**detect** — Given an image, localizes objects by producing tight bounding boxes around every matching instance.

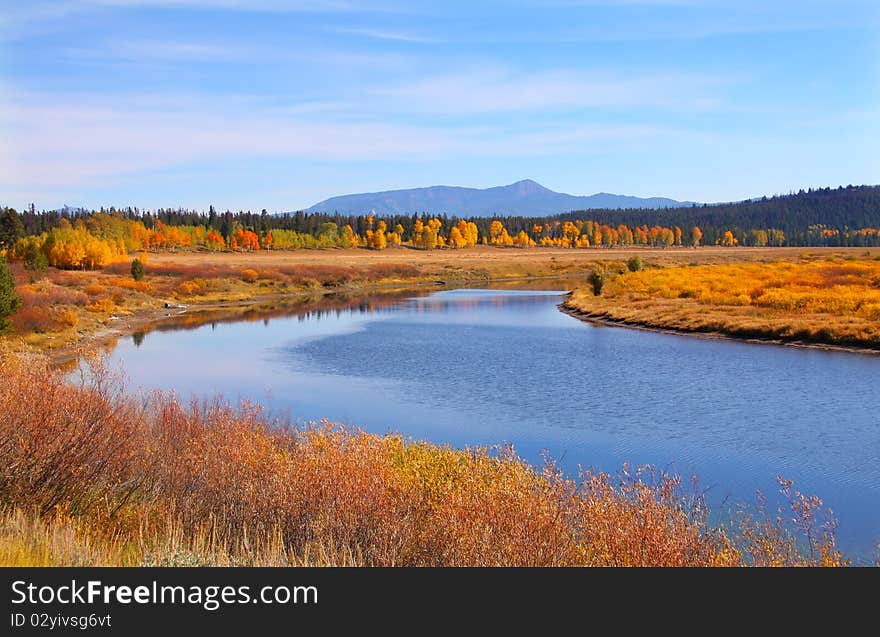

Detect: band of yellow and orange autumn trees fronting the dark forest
[0,205,812,270]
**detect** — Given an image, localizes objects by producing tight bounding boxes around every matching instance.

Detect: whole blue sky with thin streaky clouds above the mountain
[0,0,880,212]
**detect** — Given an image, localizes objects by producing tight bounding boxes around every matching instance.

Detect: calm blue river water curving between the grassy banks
[106,290,880,559]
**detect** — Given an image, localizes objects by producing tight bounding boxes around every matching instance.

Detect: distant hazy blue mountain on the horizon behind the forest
[305,179,691,216]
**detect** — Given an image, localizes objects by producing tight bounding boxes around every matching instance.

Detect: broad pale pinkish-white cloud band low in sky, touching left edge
[0,89,678,189]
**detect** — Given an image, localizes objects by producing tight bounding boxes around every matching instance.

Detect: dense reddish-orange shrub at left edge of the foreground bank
[0,352,139,514]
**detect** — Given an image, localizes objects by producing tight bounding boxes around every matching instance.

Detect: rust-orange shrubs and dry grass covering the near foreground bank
[0,350,843,566]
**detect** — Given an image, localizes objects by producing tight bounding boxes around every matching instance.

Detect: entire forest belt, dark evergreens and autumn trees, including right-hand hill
[0,186,880,267]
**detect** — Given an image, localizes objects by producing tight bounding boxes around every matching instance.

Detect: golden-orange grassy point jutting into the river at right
[566,257,880,349]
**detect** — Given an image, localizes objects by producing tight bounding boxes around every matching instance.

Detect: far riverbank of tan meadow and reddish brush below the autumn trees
[6,246,872,364]
